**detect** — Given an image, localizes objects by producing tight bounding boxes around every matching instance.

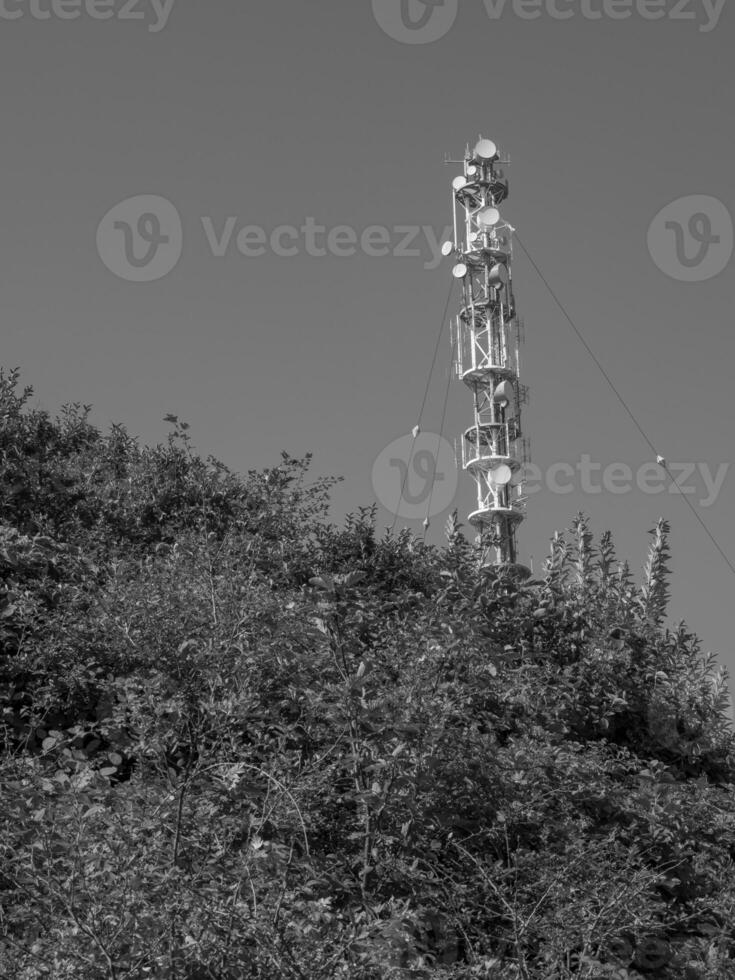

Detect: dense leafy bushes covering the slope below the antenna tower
[0,371,735,980]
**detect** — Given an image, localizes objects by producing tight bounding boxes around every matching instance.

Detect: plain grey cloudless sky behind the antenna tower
[0,0,735,704]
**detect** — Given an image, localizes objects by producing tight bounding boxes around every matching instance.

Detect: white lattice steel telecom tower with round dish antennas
[444,139,530,576]
